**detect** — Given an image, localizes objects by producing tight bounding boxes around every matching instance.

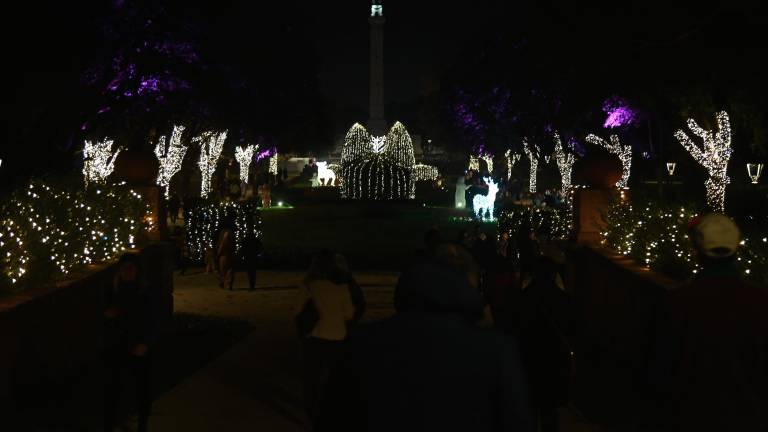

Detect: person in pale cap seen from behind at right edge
[651,214,768,432]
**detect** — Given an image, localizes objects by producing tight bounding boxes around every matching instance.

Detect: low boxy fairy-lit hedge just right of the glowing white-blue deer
[498,206,572,240]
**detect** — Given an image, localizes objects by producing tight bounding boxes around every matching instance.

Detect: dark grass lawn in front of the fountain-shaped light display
[262,200,496,270]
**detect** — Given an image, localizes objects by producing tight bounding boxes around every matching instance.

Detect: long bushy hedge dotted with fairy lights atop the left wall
[0,181,152,290]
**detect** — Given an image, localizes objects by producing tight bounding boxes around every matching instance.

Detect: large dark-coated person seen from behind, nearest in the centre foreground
[318,245,533,432]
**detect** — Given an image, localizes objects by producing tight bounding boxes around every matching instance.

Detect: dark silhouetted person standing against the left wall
[104,254,154,432]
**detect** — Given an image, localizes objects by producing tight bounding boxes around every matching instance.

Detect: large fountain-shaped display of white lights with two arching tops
[341,122,416,200]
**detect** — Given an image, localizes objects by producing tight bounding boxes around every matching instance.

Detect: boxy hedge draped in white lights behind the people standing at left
[185,200,261,262]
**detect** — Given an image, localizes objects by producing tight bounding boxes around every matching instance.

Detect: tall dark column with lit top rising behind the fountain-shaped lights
[368,0,387,136]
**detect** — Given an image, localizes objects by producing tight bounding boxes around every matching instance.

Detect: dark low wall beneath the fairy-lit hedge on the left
[0,243,174,414]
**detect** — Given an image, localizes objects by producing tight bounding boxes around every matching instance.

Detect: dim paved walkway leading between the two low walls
[138,270,601,432]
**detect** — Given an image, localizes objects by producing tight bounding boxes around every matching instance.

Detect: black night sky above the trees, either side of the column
[0,0,768,188]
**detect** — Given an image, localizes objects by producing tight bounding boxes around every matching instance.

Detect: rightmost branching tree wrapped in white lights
[675,111,733,212]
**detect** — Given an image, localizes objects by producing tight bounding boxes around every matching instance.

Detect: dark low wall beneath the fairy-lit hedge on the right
[569,246,679,426]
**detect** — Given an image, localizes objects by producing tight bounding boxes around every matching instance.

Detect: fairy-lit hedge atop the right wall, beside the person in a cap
[601,201,768,285]
